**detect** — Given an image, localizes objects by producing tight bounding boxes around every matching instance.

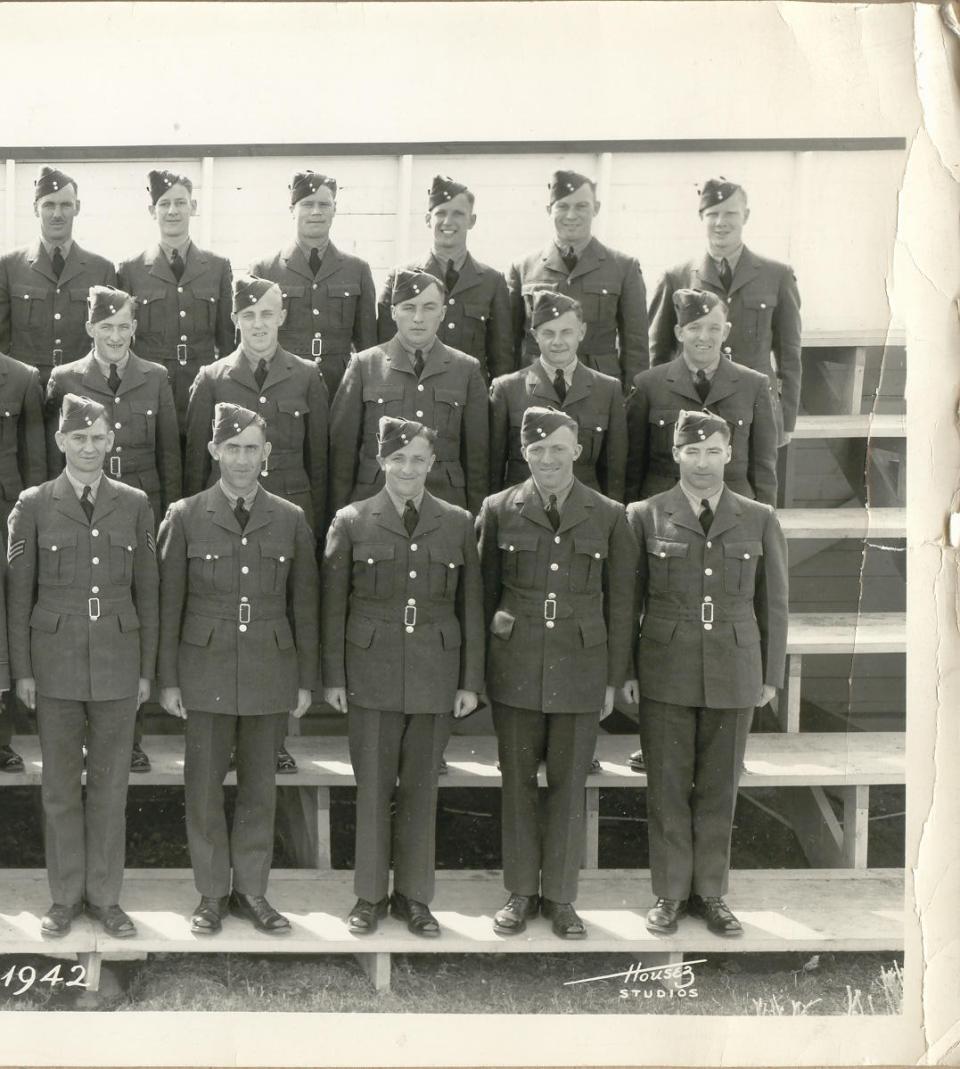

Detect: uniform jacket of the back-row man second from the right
[507,237,650,389]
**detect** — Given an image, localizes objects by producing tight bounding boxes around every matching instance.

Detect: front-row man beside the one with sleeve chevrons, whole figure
[157,401,319,934]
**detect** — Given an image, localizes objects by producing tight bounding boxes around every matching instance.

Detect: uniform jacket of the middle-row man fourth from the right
[184,346,328,531]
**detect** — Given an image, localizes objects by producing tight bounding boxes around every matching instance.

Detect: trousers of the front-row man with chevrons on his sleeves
[36,694,137,907]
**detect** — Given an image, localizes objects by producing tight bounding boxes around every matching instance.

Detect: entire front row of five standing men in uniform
[0,382,787,938]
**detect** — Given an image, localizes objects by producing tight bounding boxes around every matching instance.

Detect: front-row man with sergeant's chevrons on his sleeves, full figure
[7,393,158,936]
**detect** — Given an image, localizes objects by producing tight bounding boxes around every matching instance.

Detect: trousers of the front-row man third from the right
[346,706,453,903]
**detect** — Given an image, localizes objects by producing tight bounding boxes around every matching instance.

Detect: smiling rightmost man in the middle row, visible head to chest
[626,290,777,506]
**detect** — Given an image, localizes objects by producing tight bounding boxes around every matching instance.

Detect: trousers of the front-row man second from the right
[493,702,600,902]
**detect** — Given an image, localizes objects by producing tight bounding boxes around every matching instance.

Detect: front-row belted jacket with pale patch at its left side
[477,478,636,713]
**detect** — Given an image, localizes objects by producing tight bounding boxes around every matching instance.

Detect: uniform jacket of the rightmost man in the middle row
[626,356,777,506]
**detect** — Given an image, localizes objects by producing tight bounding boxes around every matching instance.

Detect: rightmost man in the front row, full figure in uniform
[624,412,788,935]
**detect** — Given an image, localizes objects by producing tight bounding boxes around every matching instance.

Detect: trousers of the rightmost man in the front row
[640,698,754,900]
